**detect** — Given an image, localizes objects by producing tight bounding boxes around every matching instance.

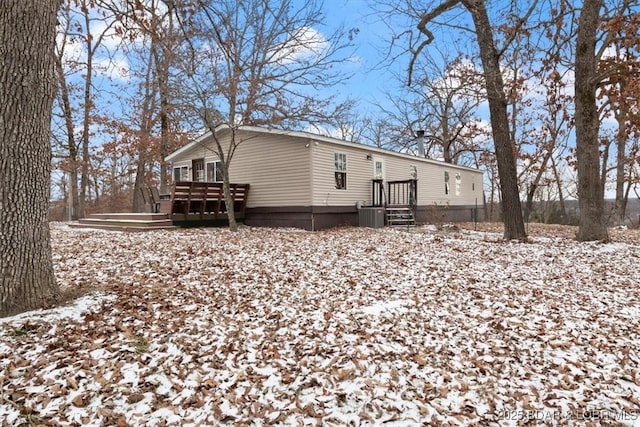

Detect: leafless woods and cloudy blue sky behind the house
[51,0,640,237]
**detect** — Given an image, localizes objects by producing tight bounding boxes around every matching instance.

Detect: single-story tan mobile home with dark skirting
[166,126,483,230]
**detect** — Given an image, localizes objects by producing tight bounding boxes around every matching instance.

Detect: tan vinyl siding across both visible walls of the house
[172,130,483,211]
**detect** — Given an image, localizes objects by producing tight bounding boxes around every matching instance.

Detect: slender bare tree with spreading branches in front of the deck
[177,0,352,230]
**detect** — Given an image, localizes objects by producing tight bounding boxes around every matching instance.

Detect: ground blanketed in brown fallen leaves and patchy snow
[0,224,640,426]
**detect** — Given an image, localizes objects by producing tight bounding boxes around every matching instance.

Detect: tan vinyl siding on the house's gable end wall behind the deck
[173,134,311,208]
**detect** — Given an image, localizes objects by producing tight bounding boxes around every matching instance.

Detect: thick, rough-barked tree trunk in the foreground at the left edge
[0,0,59,316]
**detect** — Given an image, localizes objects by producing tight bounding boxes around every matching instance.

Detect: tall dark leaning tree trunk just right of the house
[464,0,526,240]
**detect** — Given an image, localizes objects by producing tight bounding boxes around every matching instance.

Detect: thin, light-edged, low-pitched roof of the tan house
[165,125,481,172]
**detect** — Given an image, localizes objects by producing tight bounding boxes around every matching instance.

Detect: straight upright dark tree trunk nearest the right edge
[575,0,609,241]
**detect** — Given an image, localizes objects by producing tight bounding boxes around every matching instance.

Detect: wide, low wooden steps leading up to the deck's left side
[69,213,176,231]
